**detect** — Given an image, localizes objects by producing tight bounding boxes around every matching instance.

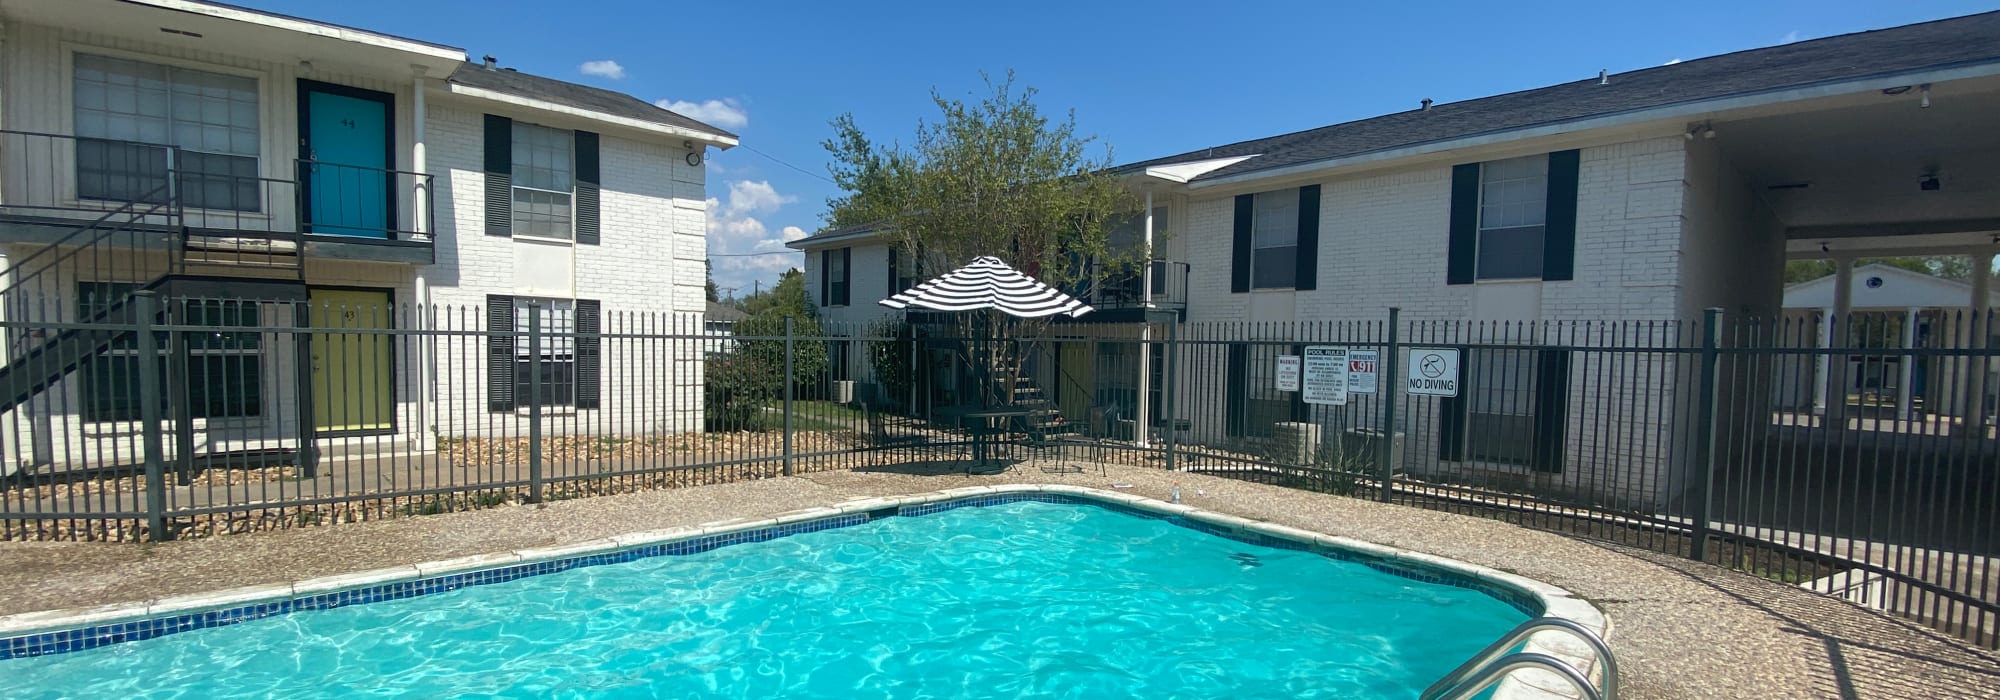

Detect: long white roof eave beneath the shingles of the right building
[1188,60,2000,190]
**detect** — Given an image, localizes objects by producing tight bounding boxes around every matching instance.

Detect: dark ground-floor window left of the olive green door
[76,282,264,420]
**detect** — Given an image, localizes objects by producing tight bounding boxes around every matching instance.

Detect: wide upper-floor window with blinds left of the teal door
[72,54,262,212]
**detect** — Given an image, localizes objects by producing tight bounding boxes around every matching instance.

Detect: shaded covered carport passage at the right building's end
[1688,70,2000,434]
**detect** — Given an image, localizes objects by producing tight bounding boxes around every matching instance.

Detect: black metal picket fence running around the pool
[0,300,2000,644]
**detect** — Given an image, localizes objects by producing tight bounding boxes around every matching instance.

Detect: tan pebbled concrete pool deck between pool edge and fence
[0,466,2000,698]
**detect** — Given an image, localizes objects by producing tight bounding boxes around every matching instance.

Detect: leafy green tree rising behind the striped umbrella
[824,72,1150,298]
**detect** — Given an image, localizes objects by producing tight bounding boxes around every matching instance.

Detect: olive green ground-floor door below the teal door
[310,288,396,432]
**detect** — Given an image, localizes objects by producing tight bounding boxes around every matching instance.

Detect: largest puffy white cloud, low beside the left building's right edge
[708,180,808,296]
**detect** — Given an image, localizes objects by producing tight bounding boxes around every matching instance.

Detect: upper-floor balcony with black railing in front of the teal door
[0,130,436,264]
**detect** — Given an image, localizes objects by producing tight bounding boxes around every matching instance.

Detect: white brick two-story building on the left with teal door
[0,0,736,466]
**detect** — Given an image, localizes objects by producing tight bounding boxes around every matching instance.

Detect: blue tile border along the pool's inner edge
[0,490,1544,660]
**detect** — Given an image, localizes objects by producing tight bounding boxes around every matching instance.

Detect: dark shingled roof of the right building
[1114,12,2000,182]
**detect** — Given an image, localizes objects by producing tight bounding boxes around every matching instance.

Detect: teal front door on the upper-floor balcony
[298,82,396,238]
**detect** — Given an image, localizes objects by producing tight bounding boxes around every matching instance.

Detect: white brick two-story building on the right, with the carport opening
[794,14,2000,506]
